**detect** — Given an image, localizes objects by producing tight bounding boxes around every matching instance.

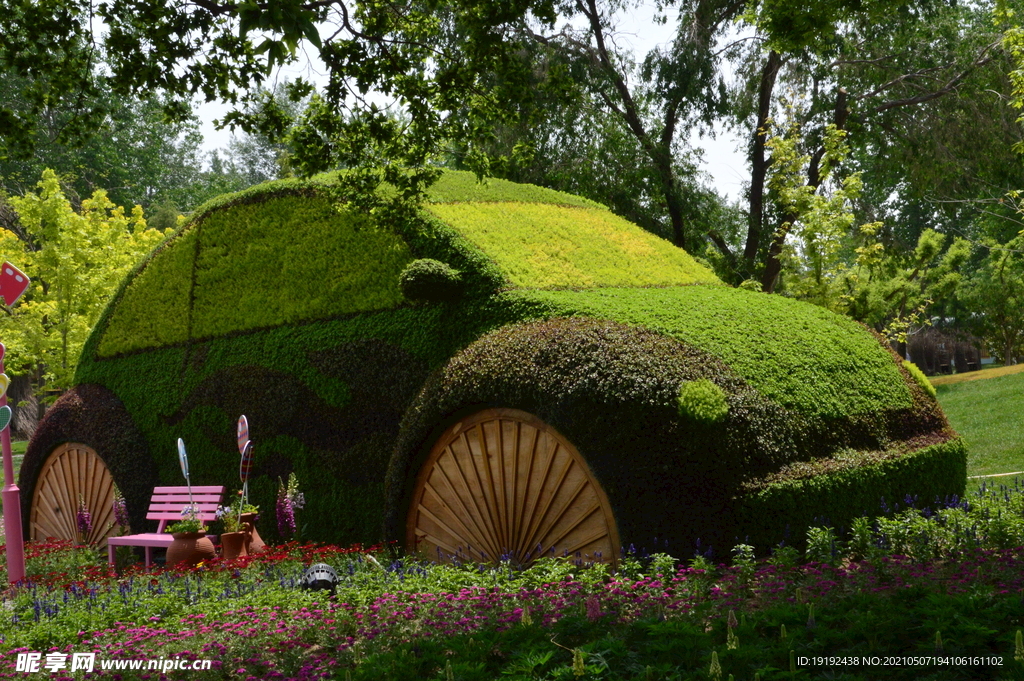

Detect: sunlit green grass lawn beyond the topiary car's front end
[935,374,1024,475]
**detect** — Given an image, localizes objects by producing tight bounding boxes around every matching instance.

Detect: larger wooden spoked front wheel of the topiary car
[406,409,618,564]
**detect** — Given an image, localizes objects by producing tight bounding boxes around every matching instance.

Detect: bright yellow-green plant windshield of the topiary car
[427,202,719,289]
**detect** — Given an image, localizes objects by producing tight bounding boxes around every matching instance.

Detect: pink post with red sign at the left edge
[0,262,29,584]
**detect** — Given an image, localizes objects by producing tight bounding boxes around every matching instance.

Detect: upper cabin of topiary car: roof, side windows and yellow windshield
[98,172,720,356]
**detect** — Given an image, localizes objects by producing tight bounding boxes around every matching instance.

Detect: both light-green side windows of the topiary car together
[99,196,413,356]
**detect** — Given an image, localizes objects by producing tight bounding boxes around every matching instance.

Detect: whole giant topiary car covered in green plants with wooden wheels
[20,172,966,562]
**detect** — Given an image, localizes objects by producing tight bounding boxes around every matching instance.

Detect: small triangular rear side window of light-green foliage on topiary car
[98,231,196,356]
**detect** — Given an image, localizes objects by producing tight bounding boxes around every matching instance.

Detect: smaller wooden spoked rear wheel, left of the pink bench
[30,442,114,545]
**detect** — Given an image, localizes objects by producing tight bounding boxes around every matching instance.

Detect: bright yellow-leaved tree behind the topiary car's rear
[0,170,166,396]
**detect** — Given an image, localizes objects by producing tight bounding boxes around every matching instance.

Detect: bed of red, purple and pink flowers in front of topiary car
[0,485,1024,681]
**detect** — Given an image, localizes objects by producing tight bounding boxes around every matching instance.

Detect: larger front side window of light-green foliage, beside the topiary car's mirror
[193,196,413,338]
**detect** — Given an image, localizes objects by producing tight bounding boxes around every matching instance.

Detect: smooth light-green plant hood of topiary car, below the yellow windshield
[507,286,912,419]
